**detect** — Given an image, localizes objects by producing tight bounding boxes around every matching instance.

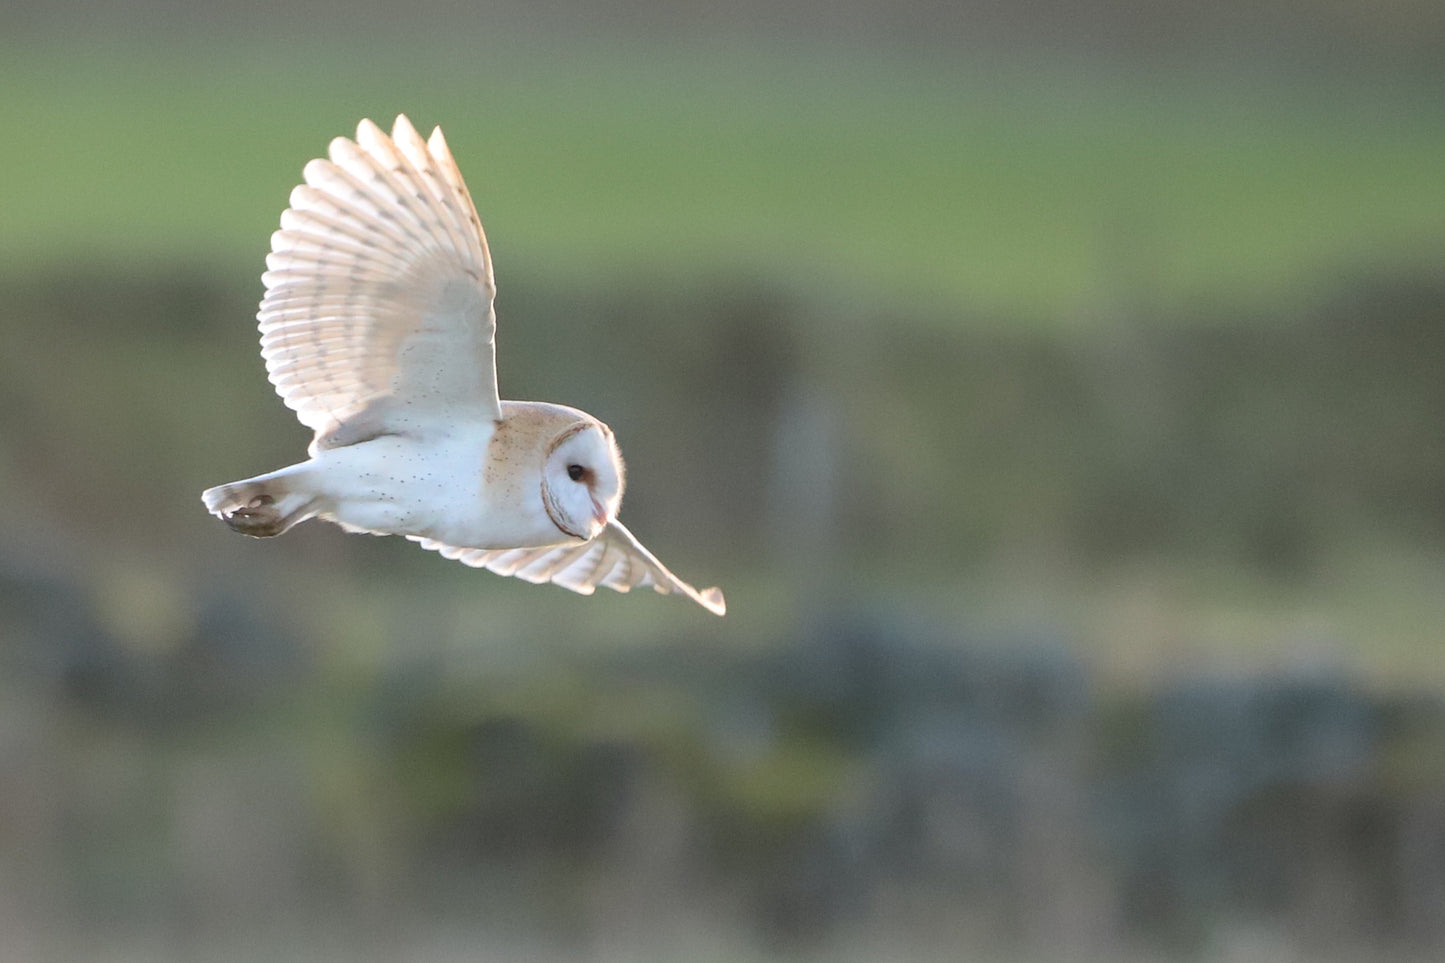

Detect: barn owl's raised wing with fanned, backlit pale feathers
[256,116,501,447]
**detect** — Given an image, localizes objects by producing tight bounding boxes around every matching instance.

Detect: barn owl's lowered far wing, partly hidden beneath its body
[407,521,727,615]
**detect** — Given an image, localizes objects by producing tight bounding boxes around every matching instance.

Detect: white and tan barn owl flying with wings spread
[201,116,724,615]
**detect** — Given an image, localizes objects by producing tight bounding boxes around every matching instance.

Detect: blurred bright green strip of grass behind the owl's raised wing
[8,39,1445,320]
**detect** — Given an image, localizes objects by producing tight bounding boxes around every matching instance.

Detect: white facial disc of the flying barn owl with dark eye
[542,421,624,541]
